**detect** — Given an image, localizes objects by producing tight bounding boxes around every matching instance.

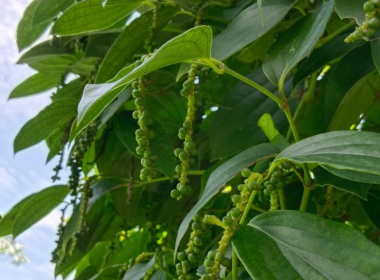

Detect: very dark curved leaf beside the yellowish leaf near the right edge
[324,44,374,124]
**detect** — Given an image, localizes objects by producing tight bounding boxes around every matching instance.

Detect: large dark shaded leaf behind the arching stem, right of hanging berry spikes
[210,68,291,160]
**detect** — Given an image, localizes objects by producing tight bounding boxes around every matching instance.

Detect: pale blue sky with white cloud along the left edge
[0,0,70,280]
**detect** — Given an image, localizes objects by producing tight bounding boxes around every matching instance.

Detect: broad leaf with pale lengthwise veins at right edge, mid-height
[275,131,380,175]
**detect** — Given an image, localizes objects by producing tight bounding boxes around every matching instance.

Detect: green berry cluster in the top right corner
[345,0,380,43]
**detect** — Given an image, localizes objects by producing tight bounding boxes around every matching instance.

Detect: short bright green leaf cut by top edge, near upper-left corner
[32,0,75,27]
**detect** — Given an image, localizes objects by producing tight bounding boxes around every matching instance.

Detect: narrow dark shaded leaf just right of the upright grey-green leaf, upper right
[293,33,365,88]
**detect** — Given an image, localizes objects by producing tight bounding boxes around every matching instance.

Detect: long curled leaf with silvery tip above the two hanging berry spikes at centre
[78,25,212,130]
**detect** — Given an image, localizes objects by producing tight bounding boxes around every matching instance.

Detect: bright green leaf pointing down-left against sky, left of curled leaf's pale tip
[13,99,78,153]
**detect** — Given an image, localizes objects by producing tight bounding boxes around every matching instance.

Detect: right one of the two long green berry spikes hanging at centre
[171,65,197,200]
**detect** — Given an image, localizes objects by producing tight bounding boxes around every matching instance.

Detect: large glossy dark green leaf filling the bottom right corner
[233,211,380,280]
